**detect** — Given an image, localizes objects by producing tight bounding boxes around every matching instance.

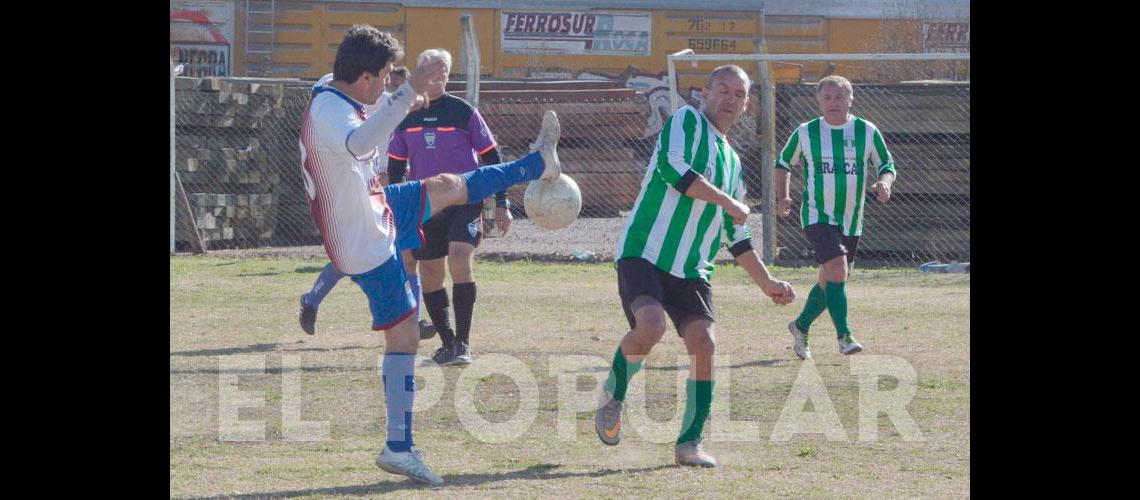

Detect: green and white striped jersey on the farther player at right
[776,115,898,236]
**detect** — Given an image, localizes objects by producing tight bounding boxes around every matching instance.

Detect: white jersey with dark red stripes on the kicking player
[301,76,410,274]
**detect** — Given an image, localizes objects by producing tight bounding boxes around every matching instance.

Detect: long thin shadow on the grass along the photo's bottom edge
[178,464,677,499]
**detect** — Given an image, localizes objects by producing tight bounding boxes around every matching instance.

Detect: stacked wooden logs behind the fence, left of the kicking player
[174,77,319,248]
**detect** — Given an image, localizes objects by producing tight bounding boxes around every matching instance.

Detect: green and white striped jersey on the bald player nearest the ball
[614,106,752,280]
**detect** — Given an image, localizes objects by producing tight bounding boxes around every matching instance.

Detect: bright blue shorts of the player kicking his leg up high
[351,177,430,330]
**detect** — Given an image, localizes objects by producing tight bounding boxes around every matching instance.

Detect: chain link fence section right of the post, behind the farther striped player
[775,83,970,264]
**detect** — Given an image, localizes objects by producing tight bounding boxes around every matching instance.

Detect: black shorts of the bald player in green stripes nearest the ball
[614,257,716,336]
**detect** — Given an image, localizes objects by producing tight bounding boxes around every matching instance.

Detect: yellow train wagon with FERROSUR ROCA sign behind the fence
[171,0,969,84]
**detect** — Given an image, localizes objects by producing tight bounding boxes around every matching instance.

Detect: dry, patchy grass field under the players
[170,256,970,498]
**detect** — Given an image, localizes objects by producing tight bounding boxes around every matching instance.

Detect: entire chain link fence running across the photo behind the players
[174,66,970,267]
